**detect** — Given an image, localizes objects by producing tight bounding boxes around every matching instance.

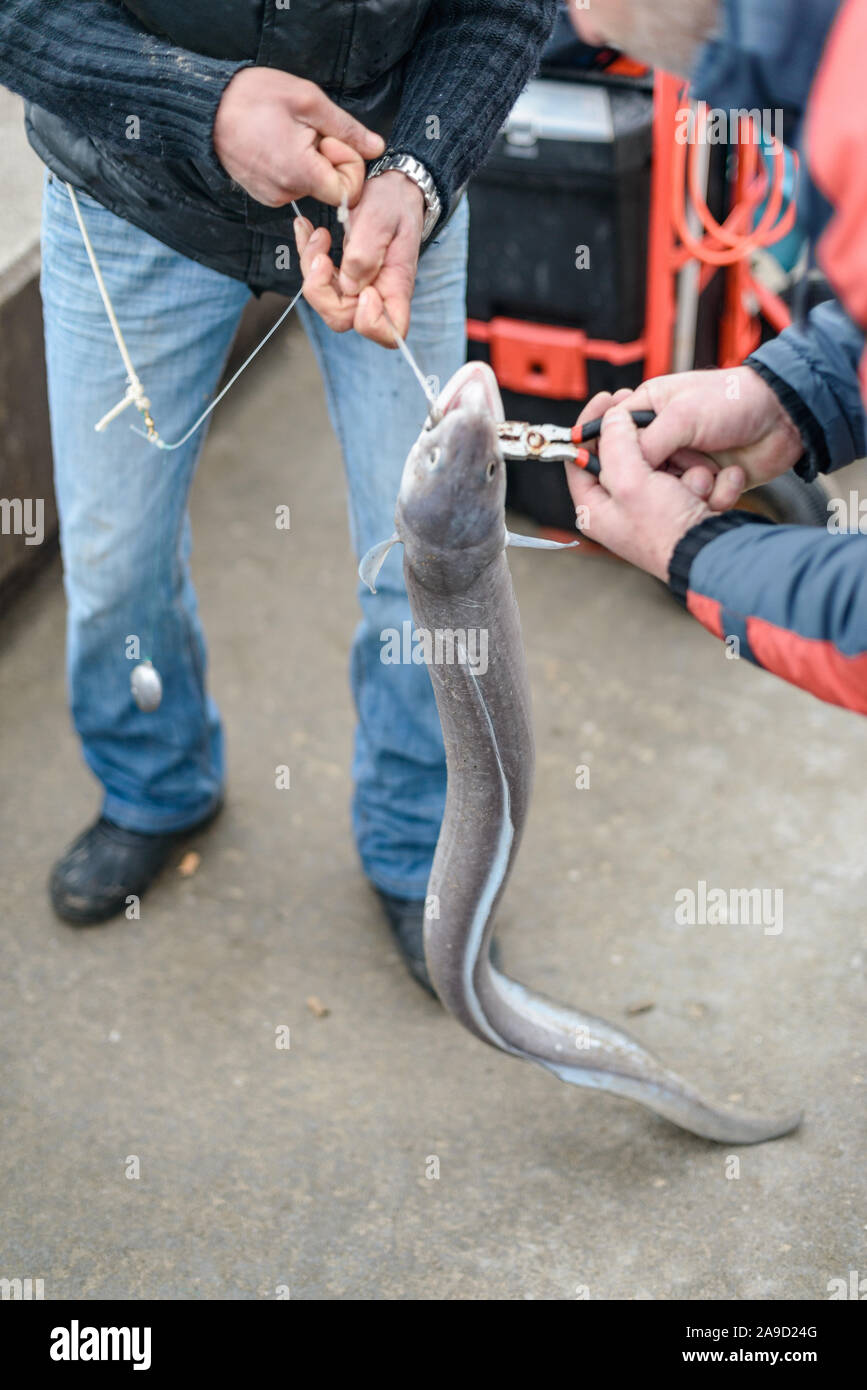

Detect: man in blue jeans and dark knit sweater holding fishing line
[0,0,556,983]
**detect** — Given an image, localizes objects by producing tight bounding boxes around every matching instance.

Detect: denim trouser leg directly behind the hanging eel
[303,199,468,898]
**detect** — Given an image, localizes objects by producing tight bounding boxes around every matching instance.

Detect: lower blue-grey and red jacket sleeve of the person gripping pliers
[668,512,867,714]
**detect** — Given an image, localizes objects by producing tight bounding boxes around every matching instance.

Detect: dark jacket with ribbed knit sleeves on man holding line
[0,0,556,293]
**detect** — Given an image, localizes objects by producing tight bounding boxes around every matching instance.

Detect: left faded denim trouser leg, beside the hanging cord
[42,179,249,833]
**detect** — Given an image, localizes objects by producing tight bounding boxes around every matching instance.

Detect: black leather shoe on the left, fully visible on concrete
[49,803,222,927]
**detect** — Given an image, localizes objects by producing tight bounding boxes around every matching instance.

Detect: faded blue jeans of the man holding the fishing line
[42,178,467,898]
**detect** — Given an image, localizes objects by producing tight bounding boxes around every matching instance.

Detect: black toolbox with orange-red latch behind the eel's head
[467,68,653,525]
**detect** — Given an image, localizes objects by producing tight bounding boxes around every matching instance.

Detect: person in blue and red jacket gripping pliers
[567,0,867,713]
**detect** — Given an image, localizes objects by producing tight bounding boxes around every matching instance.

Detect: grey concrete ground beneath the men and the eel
[0,318,867,1300]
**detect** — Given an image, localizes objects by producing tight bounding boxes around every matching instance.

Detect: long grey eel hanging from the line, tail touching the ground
[360,363,800,1144]
